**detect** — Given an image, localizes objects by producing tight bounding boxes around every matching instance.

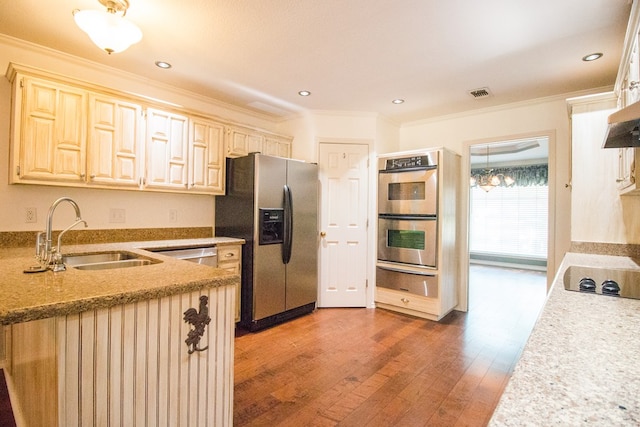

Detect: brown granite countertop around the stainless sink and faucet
[0,237,244,325]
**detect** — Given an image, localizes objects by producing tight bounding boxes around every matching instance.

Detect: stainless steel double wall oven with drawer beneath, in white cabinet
[376,151,438,297]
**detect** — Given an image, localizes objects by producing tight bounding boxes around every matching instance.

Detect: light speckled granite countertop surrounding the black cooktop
[489,253,640,426]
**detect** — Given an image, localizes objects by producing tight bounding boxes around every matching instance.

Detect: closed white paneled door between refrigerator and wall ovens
[318,143,368,307]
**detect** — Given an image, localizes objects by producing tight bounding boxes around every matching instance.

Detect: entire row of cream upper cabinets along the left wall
[7,64,291,195]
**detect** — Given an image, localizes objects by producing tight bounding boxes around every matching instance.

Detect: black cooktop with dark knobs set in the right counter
[563,265,640,299]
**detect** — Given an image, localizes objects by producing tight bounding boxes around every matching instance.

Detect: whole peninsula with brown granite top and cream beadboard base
[0,238,243,426]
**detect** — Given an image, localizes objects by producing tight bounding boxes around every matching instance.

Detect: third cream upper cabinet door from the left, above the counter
[145,108,189,190]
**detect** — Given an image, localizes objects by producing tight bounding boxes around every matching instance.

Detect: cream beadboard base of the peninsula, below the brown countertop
[7,286,236,427]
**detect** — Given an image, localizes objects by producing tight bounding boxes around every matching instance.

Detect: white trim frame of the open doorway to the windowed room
[456,130,558,311]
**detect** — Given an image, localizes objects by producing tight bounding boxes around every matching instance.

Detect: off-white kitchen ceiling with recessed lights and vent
[0,0,631,123]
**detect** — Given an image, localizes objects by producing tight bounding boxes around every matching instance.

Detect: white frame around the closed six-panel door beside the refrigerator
[316,137,378,308]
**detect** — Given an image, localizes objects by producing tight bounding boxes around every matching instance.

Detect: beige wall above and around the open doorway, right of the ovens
[400,97,571,277]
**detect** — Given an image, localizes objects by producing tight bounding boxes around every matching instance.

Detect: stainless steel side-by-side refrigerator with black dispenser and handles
[215,153,319,331]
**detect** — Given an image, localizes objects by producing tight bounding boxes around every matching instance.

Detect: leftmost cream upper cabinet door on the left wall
[11,74,87,185]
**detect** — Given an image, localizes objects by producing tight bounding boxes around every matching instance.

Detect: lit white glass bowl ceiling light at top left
[73,0,142,54]
